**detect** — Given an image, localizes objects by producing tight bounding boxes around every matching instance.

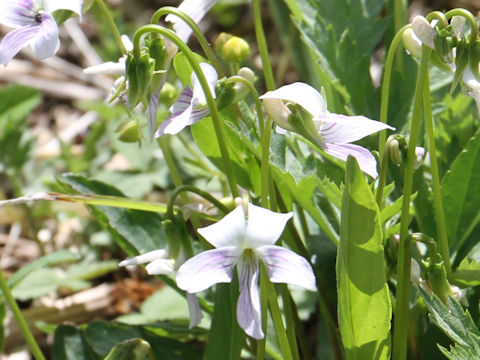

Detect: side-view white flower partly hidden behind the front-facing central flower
[118,247,202,329]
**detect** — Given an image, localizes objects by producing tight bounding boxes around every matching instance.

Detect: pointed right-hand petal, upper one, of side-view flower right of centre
[313,113,395,144]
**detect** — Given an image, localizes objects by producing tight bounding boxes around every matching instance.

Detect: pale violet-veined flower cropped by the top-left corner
[0,0,83,66]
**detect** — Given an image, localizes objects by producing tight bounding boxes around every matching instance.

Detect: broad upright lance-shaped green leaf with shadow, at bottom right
[336,157,392,360]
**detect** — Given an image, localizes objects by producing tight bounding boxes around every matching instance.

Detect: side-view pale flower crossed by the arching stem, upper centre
[155,63,218,137]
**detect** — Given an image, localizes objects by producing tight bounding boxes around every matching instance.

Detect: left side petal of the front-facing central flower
[177,246,238,293]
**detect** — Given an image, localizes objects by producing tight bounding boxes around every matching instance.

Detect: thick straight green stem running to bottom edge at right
[393,46,431,360]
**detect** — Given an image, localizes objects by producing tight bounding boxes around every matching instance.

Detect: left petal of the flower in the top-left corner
[0,0,37,28]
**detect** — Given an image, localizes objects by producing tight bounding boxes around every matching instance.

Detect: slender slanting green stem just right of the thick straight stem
[423,73,452,278]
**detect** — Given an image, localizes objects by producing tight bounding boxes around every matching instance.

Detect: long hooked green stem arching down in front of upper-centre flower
[133,24,239,197]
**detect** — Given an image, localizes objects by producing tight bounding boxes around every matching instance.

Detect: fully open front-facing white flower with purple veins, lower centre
[177,204,315,339]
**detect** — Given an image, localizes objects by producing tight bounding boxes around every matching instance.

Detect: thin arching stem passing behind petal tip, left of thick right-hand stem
[378,25,412,159]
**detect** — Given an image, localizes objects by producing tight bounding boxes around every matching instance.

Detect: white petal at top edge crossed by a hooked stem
[165,0,217,43]
